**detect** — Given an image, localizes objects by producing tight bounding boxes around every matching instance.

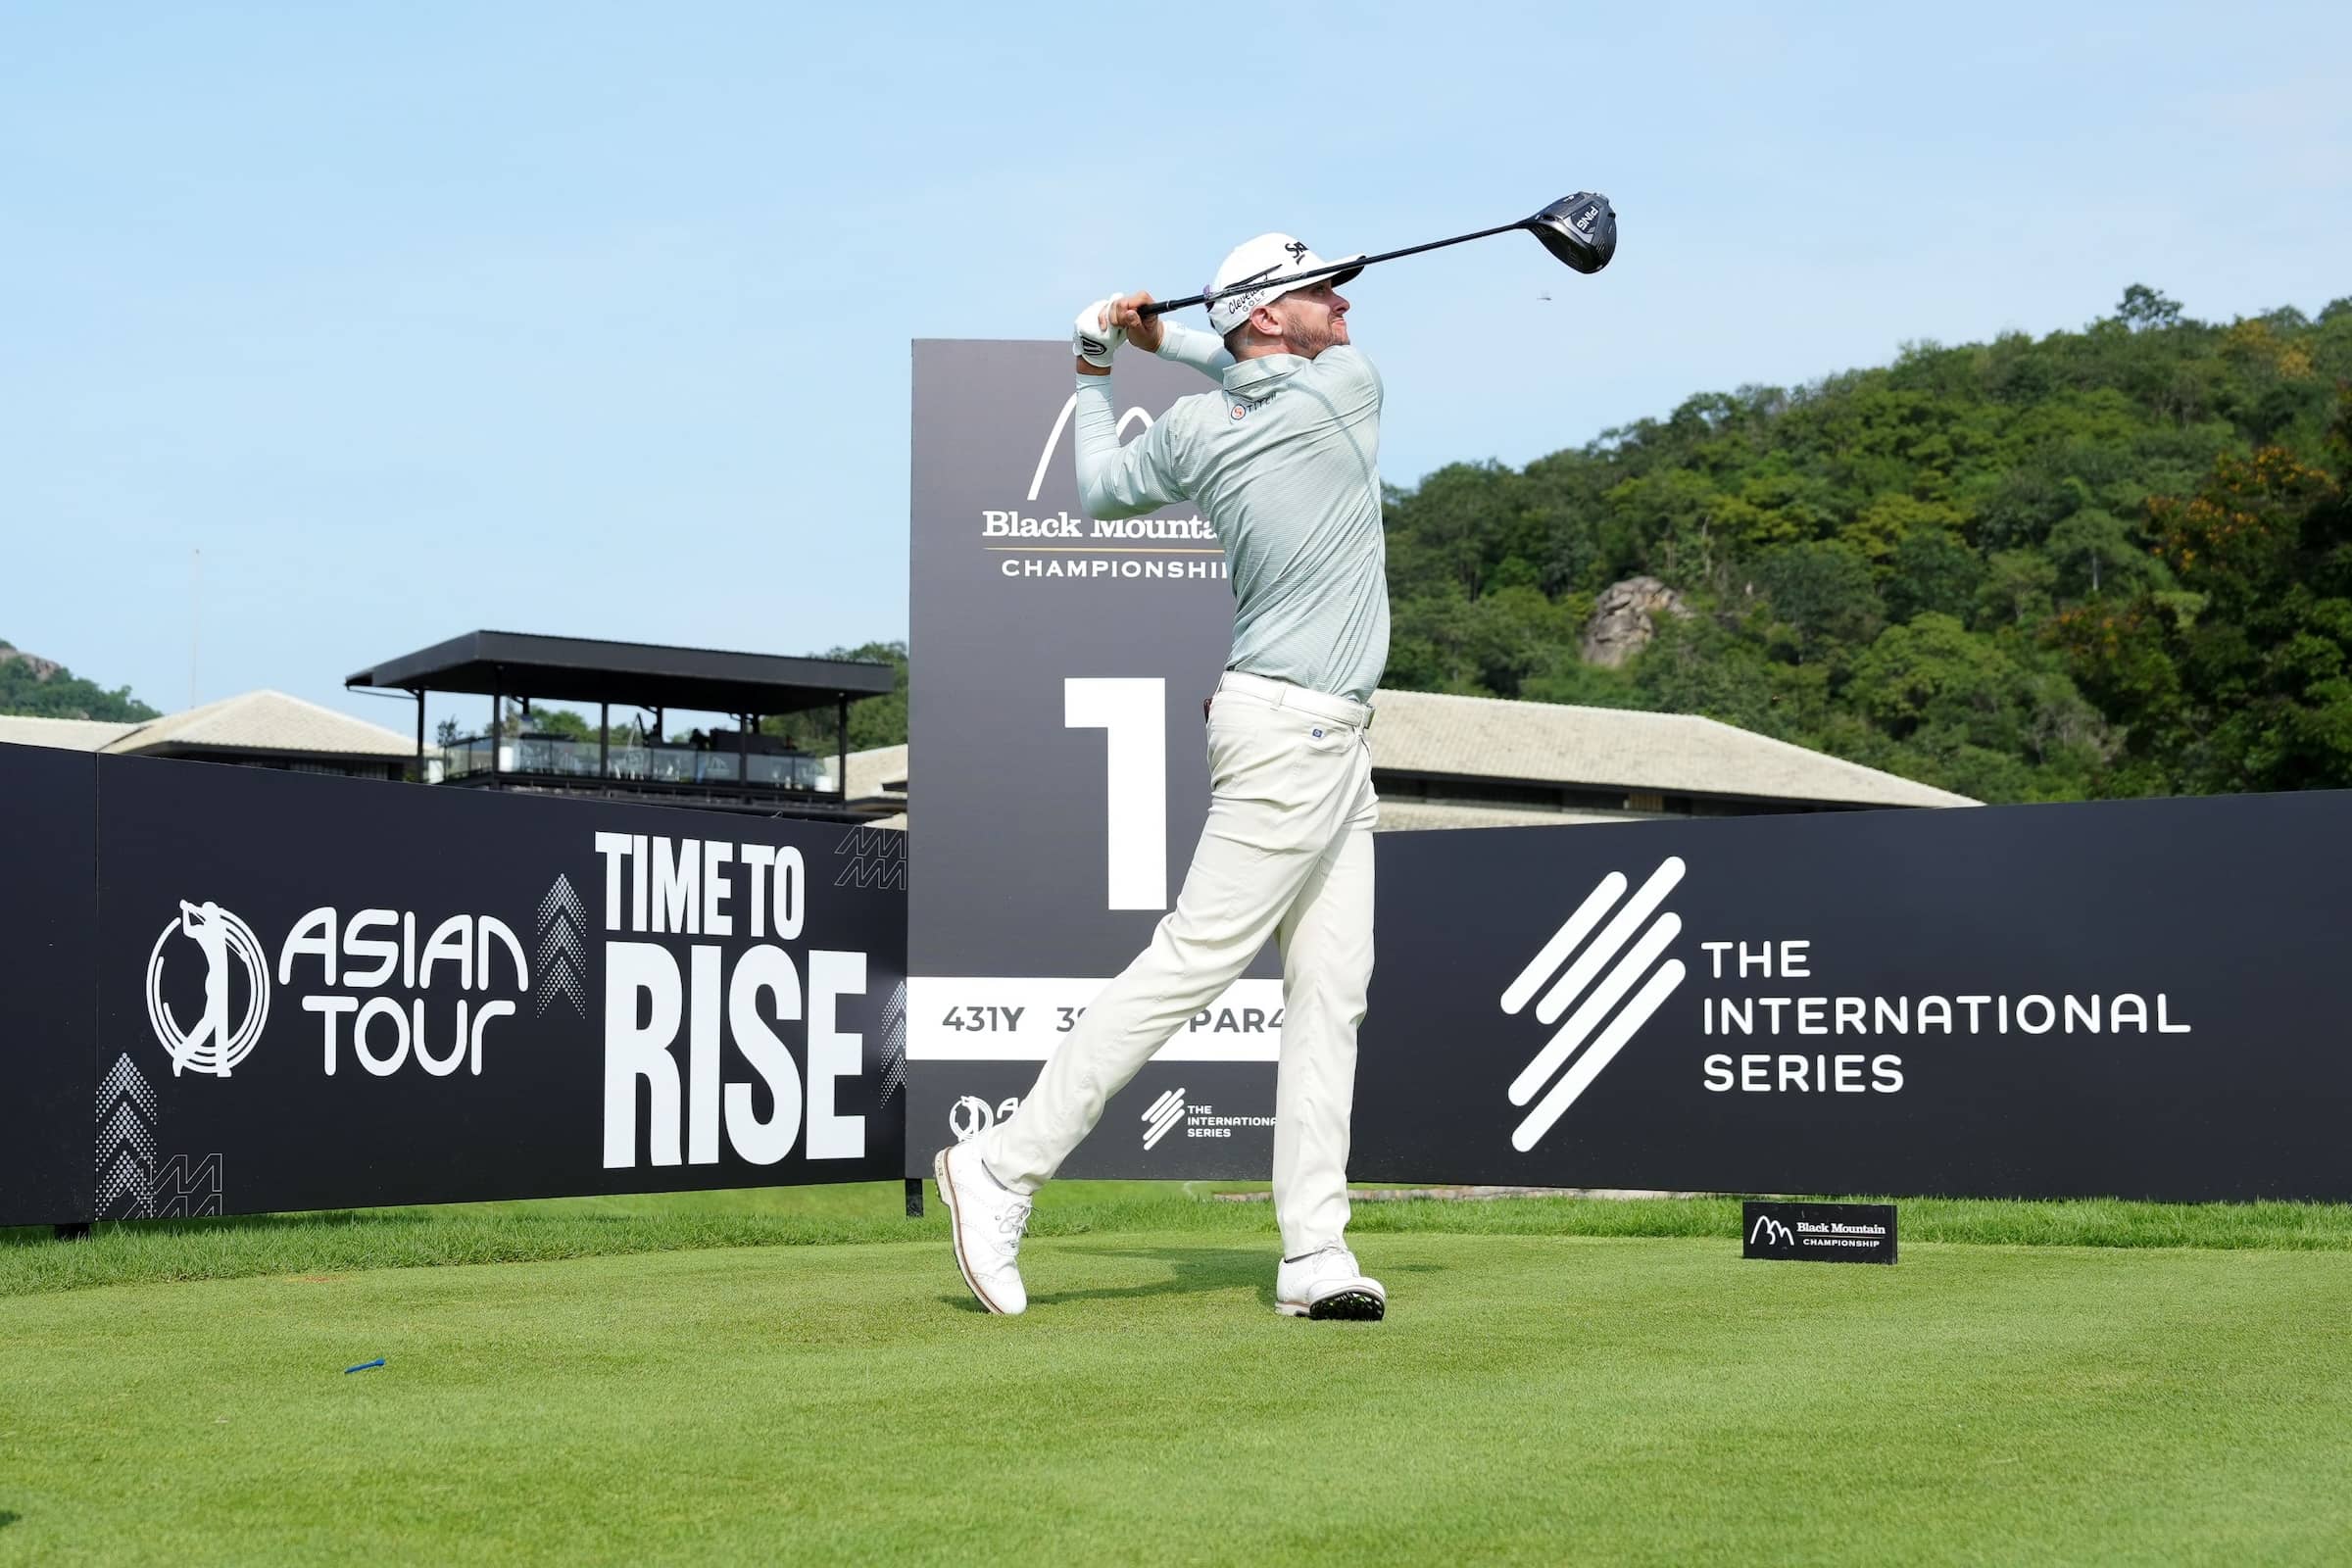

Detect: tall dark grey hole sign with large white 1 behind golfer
[907,341,1282,1178]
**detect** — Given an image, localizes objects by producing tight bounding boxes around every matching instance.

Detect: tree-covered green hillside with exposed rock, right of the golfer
[1386,287,2352,802]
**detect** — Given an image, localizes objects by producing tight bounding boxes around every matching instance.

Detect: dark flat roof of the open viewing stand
[343,632,896,712]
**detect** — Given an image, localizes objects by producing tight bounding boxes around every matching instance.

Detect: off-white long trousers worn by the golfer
[974,672,1378,1257]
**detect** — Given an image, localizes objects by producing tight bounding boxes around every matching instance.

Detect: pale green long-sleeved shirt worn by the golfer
[1072,324,1388,703]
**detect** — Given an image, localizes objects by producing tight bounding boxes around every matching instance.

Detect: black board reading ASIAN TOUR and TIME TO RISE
[80,757,906,1215]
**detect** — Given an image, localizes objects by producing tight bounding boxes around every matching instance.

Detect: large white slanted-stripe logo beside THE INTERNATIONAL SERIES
[1503,856,1684,1154]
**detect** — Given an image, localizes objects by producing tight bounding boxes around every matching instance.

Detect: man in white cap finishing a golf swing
[931,235,1388,1319]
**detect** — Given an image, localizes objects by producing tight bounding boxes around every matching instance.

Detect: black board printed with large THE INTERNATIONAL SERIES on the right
[1352,792,2352,1201]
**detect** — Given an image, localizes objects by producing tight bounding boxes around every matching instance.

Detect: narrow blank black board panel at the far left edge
[0,745,97,1225]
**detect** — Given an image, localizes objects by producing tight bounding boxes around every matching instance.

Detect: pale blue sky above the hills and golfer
[0,0,2352,729]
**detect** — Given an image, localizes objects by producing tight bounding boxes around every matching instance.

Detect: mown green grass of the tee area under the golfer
[0,1185,2352,1563]
